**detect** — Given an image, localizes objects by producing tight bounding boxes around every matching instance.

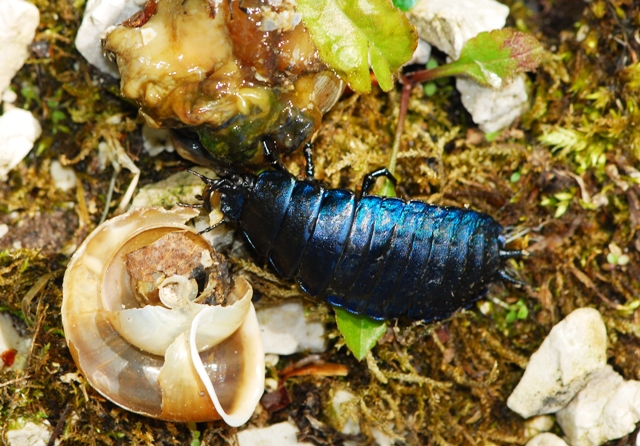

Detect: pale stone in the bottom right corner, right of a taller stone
[556,365,640,446]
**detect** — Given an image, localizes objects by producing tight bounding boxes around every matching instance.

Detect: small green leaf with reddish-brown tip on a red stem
[430,28,544,88]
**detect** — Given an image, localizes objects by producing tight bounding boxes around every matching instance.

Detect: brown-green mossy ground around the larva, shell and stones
[0,0,640,445]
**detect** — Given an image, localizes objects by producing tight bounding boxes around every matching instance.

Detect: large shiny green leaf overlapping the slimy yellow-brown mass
[298,0,418,93]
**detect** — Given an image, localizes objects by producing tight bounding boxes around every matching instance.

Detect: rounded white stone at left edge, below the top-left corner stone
[0,108,42,181]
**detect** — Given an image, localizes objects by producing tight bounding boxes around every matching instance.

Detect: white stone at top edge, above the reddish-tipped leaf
[407,0,509,59]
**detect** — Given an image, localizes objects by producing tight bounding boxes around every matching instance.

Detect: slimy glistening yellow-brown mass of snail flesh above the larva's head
[103,0,344,164]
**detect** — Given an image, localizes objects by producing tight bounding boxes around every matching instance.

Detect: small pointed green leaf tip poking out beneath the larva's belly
[334,307,387,361]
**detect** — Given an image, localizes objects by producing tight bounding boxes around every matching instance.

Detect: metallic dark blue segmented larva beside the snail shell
[198,171,520,321]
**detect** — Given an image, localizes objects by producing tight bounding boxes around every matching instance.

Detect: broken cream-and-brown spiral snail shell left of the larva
[62,208,264,426]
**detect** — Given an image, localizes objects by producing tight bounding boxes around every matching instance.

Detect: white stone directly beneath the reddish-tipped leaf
[456,75,529,133]
